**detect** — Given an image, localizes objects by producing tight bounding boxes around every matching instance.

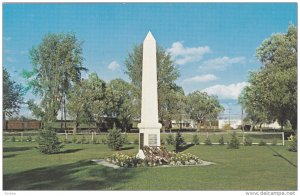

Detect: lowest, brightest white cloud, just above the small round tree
[203,82,248,99]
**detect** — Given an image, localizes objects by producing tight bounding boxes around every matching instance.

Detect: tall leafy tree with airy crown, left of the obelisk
[23,31,86,123]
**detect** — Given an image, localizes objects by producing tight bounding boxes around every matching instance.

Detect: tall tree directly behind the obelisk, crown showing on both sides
[125,44,180,128]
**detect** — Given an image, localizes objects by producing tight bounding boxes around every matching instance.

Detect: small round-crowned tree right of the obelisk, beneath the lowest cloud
[187,91,224,131]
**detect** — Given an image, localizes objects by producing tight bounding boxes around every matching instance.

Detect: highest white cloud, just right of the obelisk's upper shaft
[167,42,211,65]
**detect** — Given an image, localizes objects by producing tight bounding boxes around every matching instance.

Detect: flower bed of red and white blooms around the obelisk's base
[106,146,202,167]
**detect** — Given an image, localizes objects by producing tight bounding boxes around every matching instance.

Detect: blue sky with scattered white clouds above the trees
[2,3,297,116]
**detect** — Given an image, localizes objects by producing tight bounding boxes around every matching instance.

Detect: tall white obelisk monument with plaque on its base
[137,31,161,158]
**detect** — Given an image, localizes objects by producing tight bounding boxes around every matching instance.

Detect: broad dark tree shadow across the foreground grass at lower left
[3,161,136,190]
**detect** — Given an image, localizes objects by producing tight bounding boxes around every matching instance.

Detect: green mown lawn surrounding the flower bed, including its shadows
[3,136,297,190]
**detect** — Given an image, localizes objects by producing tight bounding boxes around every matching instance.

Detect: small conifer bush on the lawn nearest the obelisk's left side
[107,128,125,150]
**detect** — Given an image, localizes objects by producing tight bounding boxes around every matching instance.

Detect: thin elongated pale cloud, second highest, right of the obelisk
[199,56,245,71]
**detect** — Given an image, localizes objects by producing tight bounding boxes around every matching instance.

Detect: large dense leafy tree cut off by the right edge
[239,25,297,130]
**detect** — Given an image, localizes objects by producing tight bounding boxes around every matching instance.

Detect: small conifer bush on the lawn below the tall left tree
[37,128,63,154]
